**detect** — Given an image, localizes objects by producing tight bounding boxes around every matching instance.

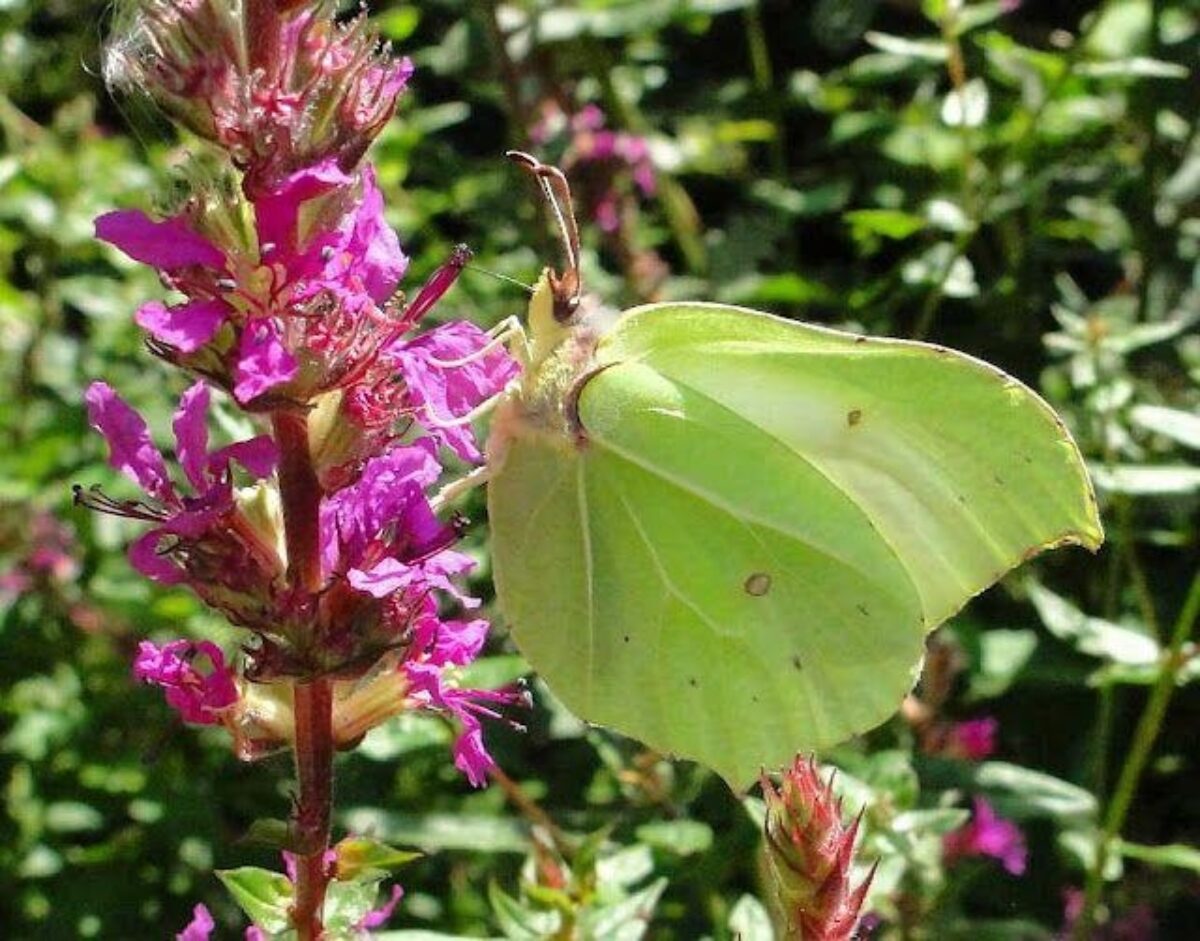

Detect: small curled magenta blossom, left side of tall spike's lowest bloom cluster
[133,641,238,725]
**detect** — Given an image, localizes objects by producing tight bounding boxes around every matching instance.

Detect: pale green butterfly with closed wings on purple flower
[472,154,1103,787]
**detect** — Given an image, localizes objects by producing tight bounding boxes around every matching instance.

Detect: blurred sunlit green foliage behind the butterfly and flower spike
[0,0,1200,940]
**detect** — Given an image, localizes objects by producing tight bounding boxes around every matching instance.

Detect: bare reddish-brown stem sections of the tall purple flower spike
[271,412,334,941]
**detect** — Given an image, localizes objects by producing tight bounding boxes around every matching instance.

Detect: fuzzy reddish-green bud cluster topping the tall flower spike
[104,0,413,197]
